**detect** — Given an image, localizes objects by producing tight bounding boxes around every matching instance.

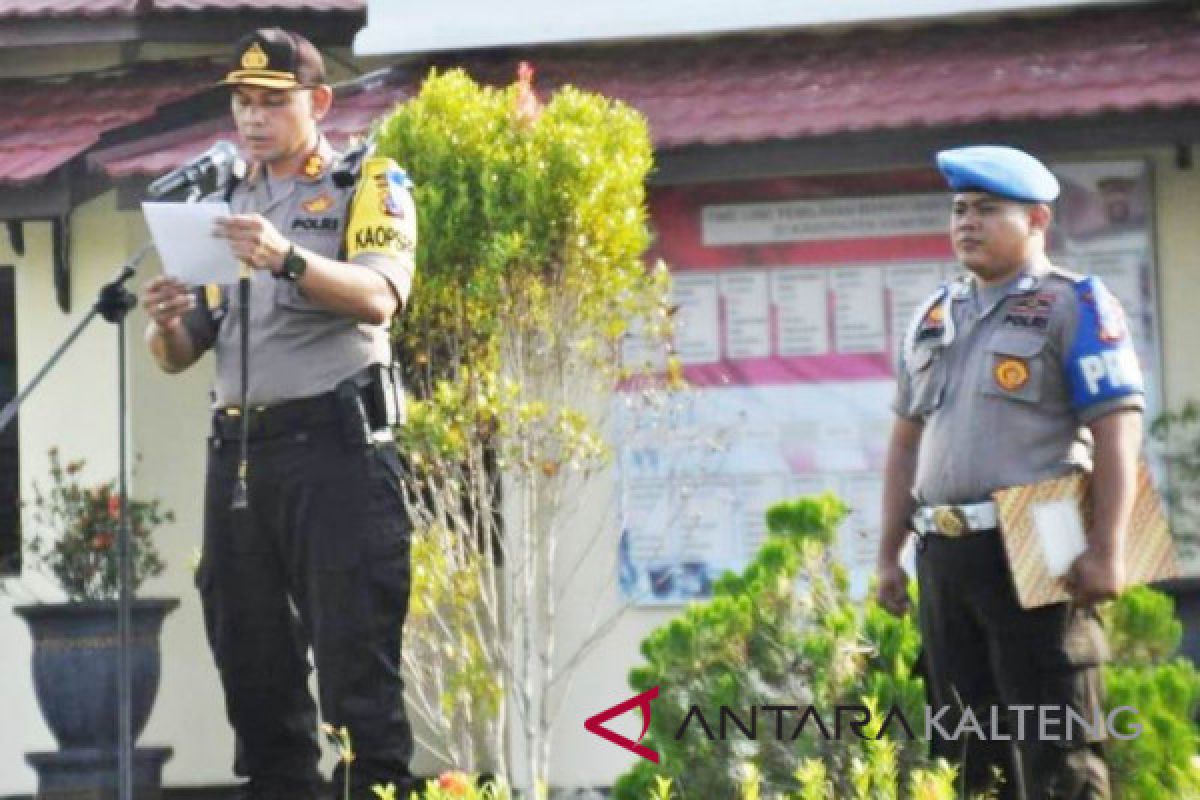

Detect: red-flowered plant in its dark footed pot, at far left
[14,447,179,799]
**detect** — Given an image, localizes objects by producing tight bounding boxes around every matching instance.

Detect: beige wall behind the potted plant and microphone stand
[0,192,232,794]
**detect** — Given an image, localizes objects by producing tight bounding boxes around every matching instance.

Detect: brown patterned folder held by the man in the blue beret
[992,462,1180,608]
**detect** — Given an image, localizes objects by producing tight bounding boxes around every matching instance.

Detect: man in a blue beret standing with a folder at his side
[877,146,1142,800]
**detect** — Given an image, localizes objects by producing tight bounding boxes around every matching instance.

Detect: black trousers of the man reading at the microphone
[197,419,413,800]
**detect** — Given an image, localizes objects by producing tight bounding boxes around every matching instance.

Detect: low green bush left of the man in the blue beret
[616,494,953,800]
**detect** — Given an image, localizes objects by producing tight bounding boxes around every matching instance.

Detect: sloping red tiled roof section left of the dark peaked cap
[0,61,216,185]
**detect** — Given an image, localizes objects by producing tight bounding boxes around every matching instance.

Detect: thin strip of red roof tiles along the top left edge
[0,0,366,18]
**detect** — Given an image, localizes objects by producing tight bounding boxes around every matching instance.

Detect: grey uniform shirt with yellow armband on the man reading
[177,138,416,408]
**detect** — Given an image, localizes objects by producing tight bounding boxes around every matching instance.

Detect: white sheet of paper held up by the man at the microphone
[142,203,240,285]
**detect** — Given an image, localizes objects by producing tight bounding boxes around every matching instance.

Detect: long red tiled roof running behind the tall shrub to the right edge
[97,6,1200,175]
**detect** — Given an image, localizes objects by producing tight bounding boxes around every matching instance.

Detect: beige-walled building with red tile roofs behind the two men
[0,0,1200,795]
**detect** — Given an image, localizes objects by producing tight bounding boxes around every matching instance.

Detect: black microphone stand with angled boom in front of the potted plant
[0,242,154,800]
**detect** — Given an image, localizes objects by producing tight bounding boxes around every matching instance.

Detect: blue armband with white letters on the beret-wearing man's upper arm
[1063,276,1145,410]
